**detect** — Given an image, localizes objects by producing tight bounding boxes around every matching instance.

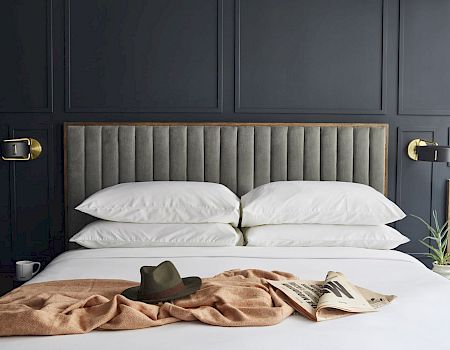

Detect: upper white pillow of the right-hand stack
[241,181,405,227]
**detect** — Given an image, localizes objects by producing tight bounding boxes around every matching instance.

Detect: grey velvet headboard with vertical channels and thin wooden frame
[64,123,388,246]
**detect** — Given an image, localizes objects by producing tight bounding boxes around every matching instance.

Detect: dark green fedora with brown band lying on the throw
[122,261,202,304]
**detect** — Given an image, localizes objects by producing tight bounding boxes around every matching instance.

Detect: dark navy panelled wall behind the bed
[0,0,450,269]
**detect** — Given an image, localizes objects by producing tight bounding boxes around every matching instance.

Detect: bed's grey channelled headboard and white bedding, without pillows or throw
[0,123,450,350]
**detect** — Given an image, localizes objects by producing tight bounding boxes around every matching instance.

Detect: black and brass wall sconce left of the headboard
[2,137,42,160]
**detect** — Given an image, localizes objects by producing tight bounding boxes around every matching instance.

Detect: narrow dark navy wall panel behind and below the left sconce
[9,123,55,262]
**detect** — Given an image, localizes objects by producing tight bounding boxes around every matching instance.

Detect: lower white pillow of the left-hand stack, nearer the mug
[70,220,243,248]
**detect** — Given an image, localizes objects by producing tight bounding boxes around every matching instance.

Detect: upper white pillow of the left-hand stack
[75,181,240,226]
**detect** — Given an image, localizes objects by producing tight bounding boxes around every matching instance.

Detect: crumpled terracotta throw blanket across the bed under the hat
[0,270,296,336]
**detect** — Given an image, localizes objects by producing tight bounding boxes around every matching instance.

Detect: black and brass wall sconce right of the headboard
[408,139,450,162]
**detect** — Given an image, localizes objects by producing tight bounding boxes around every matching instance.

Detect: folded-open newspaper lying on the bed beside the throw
[267,271,396,321]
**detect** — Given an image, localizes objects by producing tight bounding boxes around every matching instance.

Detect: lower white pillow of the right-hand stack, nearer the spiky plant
[244,224,409,249]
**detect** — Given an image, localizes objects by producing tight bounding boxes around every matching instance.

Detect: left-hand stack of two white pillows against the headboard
[70,181,242,248]
